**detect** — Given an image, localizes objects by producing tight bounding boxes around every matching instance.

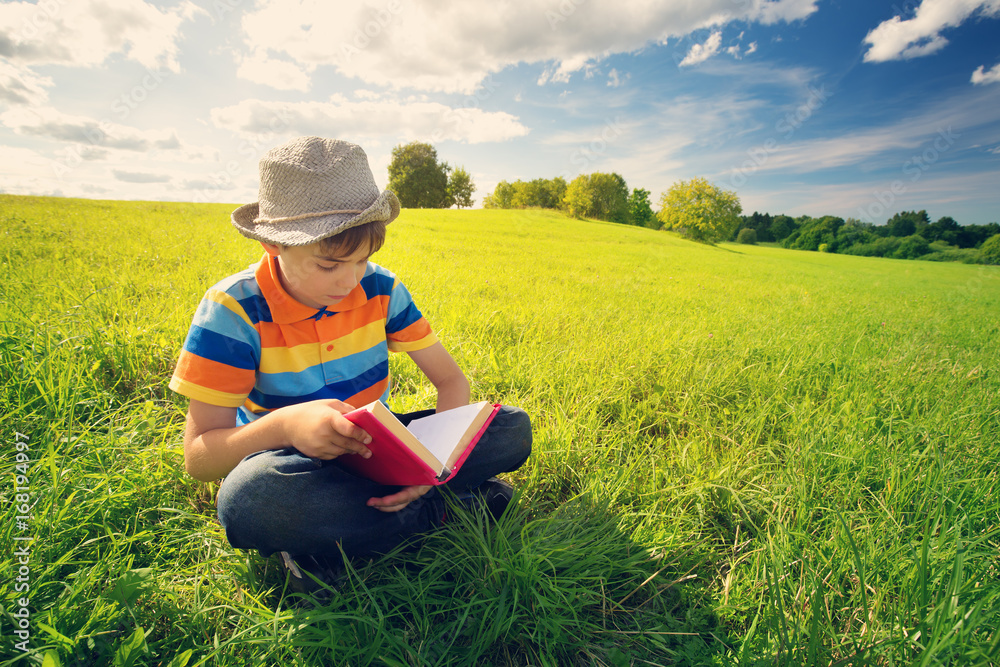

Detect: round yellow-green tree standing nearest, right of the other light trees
[658,177,743,243]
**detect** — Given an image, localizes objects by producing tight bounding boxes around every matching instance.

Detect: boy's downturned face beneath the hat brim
[263,243,371,308]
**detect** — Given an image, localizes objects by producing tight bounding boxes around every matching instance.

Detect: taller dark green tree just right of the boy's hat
[389,141,451,208]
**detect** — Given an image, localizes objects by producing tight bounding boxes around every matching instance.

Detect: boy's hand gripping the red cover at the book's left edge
[282,399,372,459]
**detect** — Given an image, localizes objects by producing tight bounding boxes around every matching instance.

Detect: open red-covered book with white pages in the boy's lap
[338,401,500,486]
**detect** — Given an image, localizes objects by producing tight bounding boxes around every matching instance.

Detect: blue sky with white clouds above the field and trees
[0,0,1000,224]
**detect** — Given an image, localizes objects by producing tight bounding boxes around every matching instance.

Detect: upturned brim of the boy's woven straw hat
[231,190,399,246]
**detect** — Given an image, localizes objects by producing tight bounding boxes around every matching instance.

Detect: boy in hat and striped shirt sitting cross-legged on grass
[170,137,531,590]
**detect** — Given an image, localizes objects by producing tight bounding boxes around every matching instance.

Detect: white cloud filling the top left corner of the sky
[0,0,205,72]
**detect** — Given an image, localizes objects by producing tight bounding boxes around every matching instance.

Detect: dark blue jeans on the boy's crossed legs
[217,406,531,556]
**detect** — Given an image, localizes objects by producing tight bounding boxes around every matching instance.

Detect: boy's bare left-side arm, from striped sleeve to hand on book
[184,399,371,482]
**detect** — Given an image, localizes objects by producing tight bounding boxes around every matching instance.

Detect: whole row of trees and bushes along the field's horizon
[389,142,1000,264]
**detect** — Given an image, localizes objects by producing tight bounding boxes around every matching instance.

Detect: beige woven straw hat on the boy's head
[232,137,399,246]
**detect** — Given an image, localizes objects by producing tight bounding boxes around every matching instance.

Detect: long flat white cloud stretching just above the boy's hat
[211,96,528,144]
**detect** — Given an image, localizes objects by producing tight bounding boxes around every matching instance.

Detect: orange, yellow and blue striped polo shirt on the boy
[170,254,437,424]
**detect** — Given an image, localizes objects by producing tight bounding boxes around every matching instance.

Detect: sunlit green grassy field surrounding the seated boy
[0,196,1000,667]
